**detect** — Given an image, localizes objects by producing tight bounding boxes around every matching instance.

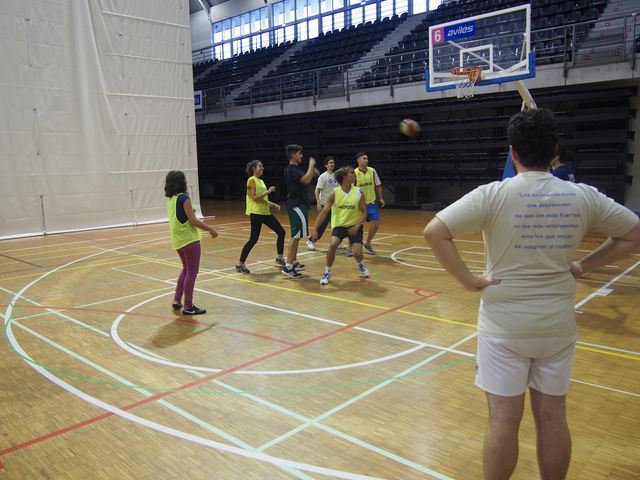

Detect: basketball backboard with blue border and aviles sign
[426,4,535,92]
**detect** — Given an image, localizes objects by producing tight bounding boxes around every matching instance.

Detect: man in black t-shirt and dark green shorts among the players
[282,144,319,278]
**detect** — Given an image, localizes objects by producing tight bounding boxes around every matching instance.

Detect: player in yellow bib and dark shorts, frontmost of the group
[312,167,369,285]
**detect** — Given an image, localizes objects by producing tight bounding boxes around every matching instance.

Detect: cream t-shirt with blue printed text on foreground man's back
[436,171,638,338]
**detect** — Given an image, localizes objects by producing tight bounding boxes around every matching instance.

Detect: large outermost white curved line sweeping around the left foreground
[3,242,380,480]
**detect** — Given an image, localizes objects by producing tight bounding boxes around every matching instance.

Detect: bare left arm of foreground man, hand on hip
[423,217,500,292]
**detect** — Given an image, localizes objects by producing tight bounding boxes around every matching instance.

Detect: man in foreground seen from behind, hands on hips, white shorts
[424,109,640,480]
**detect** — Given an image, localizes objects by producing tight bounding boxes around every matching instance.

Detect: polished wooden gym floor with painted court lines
[0,202,640,480]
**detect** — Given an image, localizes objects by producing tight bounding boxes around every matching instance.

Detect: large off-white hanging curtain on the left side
[0,0,200,238]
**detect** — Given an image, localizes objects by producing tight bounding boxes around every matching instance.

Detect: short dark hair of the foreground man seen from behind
[508,108,558,170]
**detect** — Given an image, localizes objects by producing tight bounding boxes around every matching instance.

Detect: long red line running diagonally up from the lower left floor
[0,289,435,464]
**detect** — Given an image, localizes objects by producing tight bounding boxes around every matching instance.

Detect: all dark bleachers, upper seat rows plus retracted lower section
[194,0,640,207]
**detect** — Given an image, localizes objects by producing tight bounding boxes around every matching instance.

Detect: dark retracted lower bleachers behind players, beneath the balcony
[197,86,638,204]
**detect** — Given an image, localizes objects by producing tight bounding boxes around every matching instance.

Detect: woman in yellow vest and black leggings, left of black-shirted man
[236,160,286,273]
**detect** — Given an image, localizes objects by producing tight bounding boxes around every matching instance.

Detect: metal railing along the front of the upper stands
[194,13,640,113]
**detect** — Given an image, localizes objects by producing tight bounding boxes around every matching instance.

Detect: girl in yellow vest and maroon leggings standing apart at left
[164,170,218,315]
